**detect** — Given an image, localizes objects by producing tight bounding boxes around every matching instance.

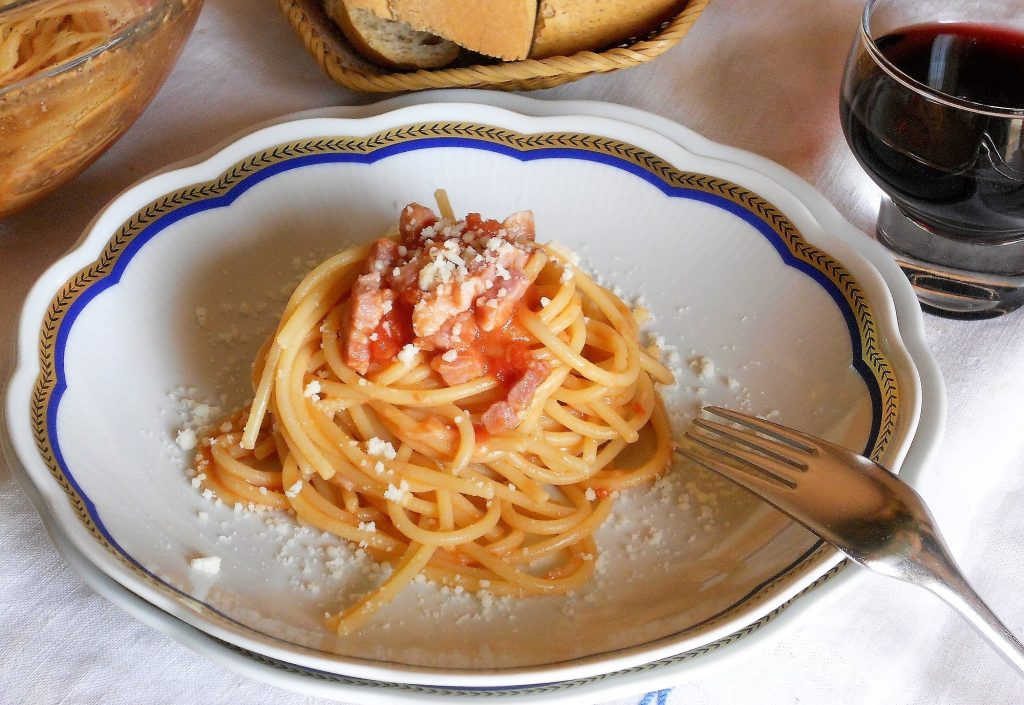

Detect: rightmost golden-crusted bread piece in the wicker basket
[532,0,686,58]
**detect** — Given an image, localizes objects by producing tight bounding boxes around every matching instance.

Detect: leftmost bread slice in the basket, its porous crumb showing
[324,0,459,69]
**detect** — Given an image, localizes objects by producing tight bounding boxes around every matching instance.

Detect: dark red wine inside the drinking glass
[841,23,1024,240]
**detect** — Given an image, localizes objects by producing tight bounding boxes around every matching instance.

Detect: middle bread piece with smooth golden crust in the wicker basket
[345,0,537,61]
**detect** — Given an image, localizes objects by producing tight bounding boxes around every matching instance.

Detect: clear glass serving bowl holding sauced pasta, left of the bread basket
[0,0,203,217]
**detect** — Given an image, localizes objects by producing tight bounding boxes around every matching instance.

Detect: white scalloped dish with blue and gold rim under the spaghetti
[7,99,937,687]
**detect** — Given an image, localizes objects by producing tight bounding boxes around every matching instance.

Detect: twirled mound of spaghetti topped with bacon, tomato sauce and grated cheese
[197,192,673,634]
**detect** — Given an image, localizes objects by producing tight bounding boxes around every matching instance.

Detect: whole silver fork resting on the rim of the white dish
[677,407,1024,672]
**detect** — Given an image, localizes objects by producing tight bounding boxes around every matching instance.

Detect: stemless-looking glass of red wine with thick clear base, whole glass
[840,0,1024,319]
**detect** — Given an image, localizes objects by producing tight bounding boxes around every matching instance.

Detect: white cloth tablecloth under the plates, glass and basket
[0,0,1024,705]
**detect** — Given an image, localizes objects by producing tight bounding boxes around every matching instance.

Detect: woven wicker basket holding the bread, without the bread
[279,0,710,93]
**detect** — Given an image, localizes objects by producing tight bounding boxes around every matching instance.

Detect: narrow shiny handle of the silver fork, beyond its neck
[922,549,1024,673]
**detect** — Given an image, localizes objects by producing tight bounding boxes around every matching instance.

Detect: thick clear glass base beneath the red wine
[878,199,1024,319]
